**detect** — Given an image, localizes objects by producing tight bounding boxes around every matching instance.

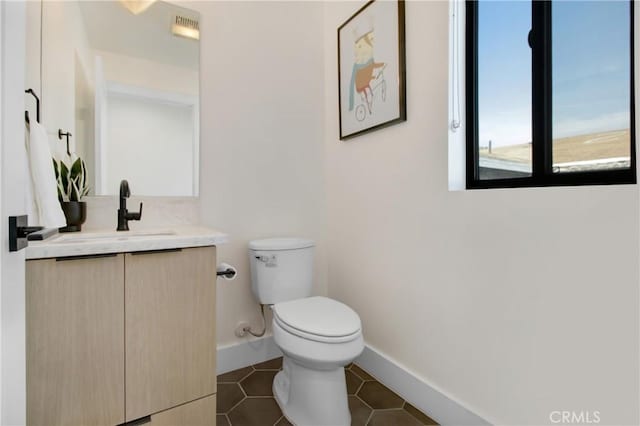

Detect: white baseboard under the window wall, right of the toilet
[354,345,491,425]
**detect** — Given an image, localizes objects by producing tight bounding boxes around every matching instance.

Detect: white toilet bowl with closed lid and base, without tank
[272,297,364,426]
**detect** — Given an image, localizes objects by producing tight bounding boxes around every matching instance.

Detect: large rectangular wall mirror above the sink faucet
[33,0,200,196]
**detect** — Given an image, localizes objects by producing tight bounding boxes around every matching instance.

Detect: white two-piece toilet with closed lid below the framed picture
[249,238,364,426]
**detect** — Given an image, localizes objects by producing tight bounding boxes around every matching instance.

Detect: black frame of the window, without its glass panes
[465,0,637,189]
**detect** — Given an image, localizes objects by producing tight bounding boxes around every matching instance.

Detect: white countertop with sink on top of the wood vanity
[26,225,228,259]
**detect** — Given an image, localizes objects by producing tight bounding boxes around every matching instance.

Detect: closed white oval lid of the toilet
[273,296,361,338]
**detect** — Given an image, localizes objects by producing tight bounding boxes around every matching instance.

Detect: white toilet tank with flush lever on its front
[249,238,315,305]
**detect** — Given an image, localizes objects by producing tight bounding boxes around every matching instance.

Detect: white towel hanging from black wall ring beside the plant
[29,120,67,228]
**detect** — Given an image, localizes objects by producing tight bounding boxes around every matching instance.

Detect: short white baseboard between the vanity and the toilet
[216,336,282,374]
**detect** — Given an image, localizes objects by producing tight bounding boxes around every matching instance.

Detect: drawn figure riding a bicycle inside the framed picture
[349,19,386,121]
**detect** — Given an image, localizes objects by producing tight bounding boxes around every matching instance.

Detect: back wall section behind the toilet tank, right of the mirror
[196,1,326,347]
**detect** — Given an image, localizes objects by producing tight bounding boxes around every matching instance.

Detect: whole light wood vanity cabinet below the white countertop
[26,246,216,426]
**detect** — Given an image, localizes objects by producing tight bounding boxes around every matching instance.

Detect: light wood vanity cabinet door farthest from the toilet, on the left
[26,254,124,426]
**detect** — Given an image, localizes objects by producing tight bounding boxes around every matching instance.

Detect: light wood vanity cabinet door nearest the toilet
[125,247,216,421]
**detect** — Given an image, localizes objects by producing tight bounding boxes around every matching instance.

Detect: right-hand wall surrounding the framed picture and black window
[324,1,640,425]
